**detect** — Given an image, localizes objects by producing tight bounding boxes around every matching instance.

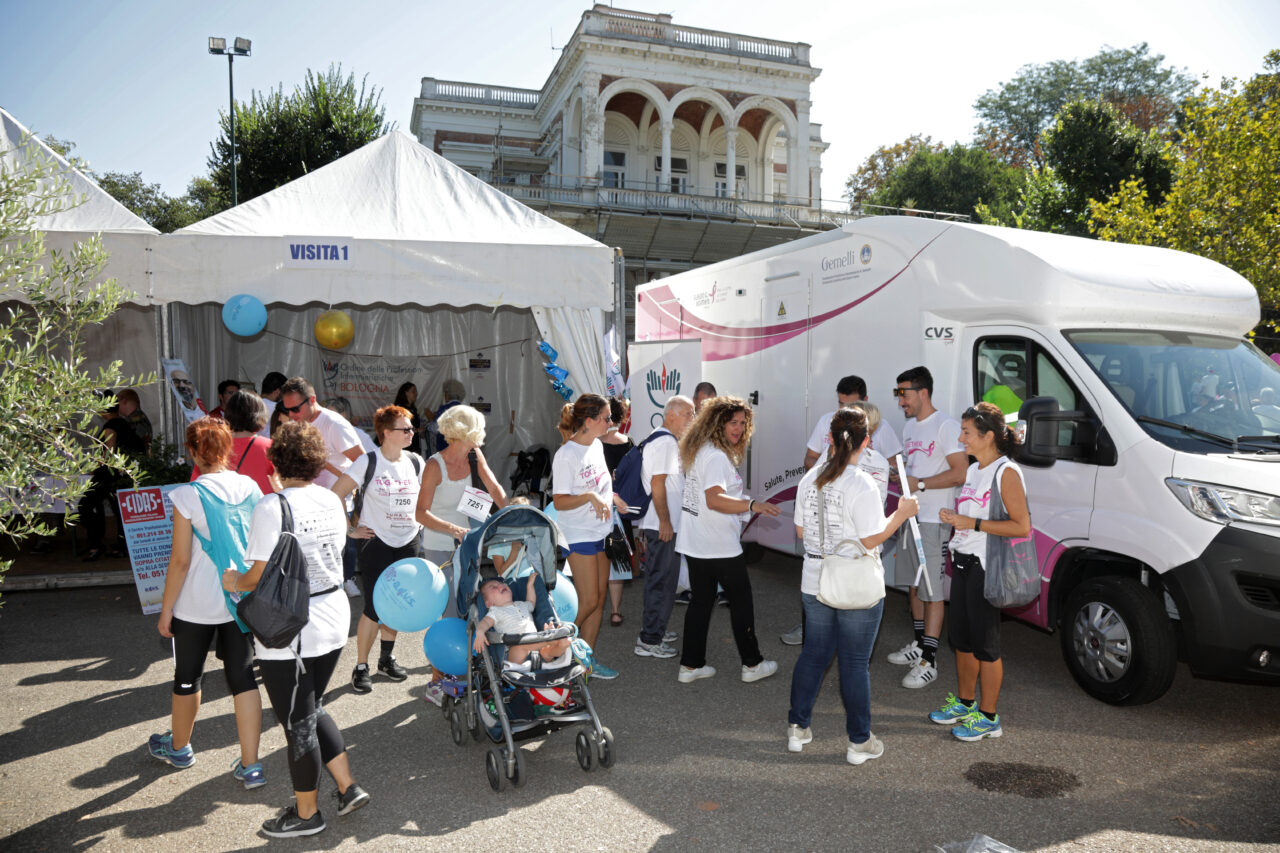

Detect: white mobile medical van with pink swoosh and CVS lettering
[635,216,1280,704]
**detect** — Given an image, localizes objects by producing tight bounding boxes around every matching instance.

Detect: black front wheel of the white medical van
[1061,578,1178,704]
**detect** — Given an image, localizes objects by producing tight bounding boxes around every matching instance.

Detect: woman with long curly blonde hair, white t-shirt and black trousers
[676,397,778,684]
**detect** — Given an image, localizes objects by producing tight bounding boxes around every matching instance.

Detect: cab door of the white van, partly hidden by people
[957,327,1098,625]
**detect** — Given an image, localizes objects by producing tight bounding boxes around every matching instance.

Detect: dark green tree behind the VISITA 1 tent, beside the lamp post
[209,65,393,201]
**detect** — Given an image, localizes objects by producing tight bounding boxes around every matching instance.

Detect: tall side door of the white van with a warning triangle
[744,278,809,553]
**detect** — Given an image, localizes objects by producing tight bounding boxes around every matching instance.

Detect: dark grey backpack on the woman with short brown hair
[236,494,312,648]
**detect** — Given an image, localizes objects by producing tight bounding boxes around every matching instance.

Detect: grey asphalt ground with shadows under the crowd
[0,555,1280,853]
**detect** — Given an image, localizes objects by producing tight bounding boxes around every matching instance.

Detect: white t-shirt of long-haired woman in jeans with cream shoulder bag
[792,465,888,596]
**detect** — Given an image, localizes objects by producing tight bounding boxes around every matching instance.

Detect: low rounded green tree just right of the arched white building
[867,142,1024,216]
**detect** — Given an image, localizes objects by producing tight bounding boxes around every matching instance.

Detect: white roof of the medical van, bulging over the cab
[641,216,1261,337]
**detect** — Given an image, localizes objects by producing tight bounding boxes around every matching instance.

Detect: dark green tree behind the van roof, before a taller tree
[978,101,1172,237]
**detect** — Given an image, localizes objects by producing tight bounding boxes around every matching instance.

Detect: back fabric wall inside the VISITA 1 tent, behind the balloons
[173,304,562,487]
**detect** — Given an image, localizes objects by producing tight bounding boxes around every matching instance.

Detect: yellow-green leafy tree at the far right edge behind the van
[1089,50,1280,322]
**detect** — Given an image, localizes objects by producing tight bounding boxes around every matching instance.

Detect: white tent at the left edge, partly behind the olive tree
[0,109,161,414]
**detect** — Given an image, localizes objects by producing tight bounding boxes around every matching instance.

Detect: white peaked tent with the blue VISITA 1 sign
[148,132,613,468]
